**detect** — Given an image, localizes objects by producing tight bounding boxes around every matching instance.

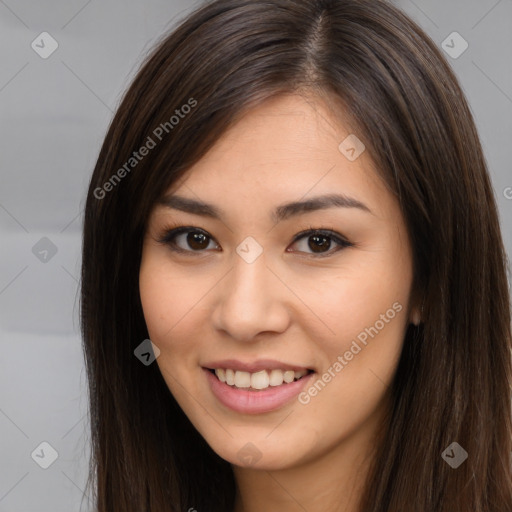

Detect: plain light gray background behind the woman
[0,0,512,512]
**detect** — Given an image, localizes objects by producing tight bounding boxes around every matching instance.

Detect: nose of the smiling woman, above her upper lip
[211,255,291,341]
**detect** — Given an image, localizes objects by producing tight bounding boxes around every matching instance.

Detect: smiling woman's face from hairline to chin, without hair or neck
[140,95,413,469]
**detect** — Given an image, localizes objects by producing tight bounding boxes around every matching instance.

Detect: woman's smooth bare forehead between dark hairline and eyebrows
[162,95,390,222]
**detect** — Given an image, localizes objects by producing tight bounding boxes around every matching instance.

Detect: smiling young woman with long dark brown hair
[81,0,512,512]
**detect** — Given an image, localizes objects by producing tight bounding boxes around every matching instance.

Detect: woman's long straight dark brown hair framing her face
[81,0,512,512]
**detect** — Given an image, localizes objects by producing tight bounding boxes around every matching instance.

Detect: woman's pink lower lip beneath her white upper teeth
[203,368,315,414]
